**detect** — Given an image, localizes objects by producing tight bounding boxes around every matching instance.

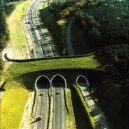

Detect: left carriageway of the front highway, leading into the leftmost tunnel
[32,80,50,129]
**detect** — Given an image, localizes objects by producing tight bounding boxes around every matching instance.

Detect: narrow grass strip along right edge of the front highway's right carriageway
[66,89,76,129]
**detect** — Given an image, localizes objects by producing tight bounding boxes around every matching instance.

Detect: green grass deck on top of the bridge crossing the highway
[3,54,100,79]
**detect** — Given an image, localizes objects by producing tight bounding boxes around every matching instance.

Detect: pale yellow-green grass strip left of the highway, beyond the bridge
[7,0,31,58]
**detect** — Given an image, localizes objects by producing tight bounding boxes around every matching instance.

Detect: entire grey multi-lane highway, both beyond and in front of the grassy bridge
[24,0,65,129]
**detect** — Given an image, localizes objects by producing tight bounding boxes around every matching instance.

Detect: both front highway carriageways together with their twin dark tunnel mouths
[32,76,66,129]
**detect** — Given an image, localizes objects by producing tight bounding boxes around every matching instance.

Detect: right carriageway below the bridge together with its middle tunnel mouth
[51,74,66,129]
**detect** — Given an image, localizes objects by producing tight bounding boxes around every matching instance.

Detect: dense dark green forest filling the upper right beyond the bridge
[46,0,129,61]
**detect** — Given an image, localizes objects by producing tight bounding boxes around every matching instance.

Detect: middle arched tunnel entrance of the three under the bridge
[51,74,67,87]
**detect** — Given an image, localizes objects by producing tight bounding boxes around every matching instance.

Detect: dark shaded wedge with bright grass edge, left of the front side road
[70,85,92,129]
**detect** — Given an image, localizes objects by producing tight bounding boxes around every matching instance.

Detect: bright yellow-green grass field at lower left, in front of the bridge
[1,81,28,129]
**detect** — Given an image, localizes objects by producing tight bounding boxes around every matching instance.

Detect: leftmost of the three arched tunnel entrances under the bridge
[35,75,51,89]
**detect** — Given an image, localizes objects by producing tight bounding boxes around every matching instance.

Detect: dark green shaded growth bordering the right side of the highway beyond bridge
[40,7,66,55]
